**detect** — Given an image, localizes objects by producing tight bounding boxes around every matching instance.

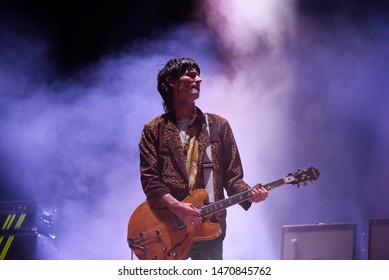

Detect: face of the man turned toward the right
[171,68,202,103]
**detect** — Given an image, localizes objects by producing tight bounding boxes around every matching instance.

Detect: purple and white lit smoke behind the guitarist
[0,0,389,259]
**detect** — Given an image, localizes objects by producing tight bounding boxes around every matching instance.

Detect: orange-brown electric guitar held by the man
[127,167,320,260]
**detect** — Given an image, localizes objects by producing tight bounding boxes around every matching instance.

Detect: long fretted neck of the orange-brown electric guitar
[201,177,289,217]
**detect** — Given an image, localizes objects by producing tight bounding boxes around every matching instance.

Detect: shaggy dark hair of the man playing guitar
[157,58,200,113]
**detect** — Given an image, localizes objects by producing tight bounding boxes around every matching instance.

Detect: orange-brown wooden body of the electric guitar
[127,190,221,260]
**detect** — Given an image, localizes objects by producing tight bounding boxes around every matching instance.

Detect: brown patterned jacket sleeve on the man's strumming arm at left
[139,124,170,199]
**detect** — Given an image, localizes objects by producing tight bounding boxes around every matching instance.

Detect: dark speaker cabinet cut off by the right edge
[368,219,389,260]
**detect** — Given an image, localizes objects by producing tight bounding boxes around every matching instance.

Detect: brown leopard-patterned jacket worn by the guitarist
[139,108,251,238]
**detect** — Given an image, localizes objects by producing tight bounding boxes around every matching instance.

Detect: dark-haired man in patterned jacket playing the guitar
[139,58,268,259]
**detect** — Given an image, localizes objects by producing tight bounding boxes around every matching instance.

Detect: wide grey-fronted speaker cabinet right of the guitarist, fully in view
[281,223,356,260]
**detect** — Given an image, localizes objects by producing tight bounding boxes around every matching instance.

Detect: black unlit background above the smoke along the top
[0,0,389,75]
